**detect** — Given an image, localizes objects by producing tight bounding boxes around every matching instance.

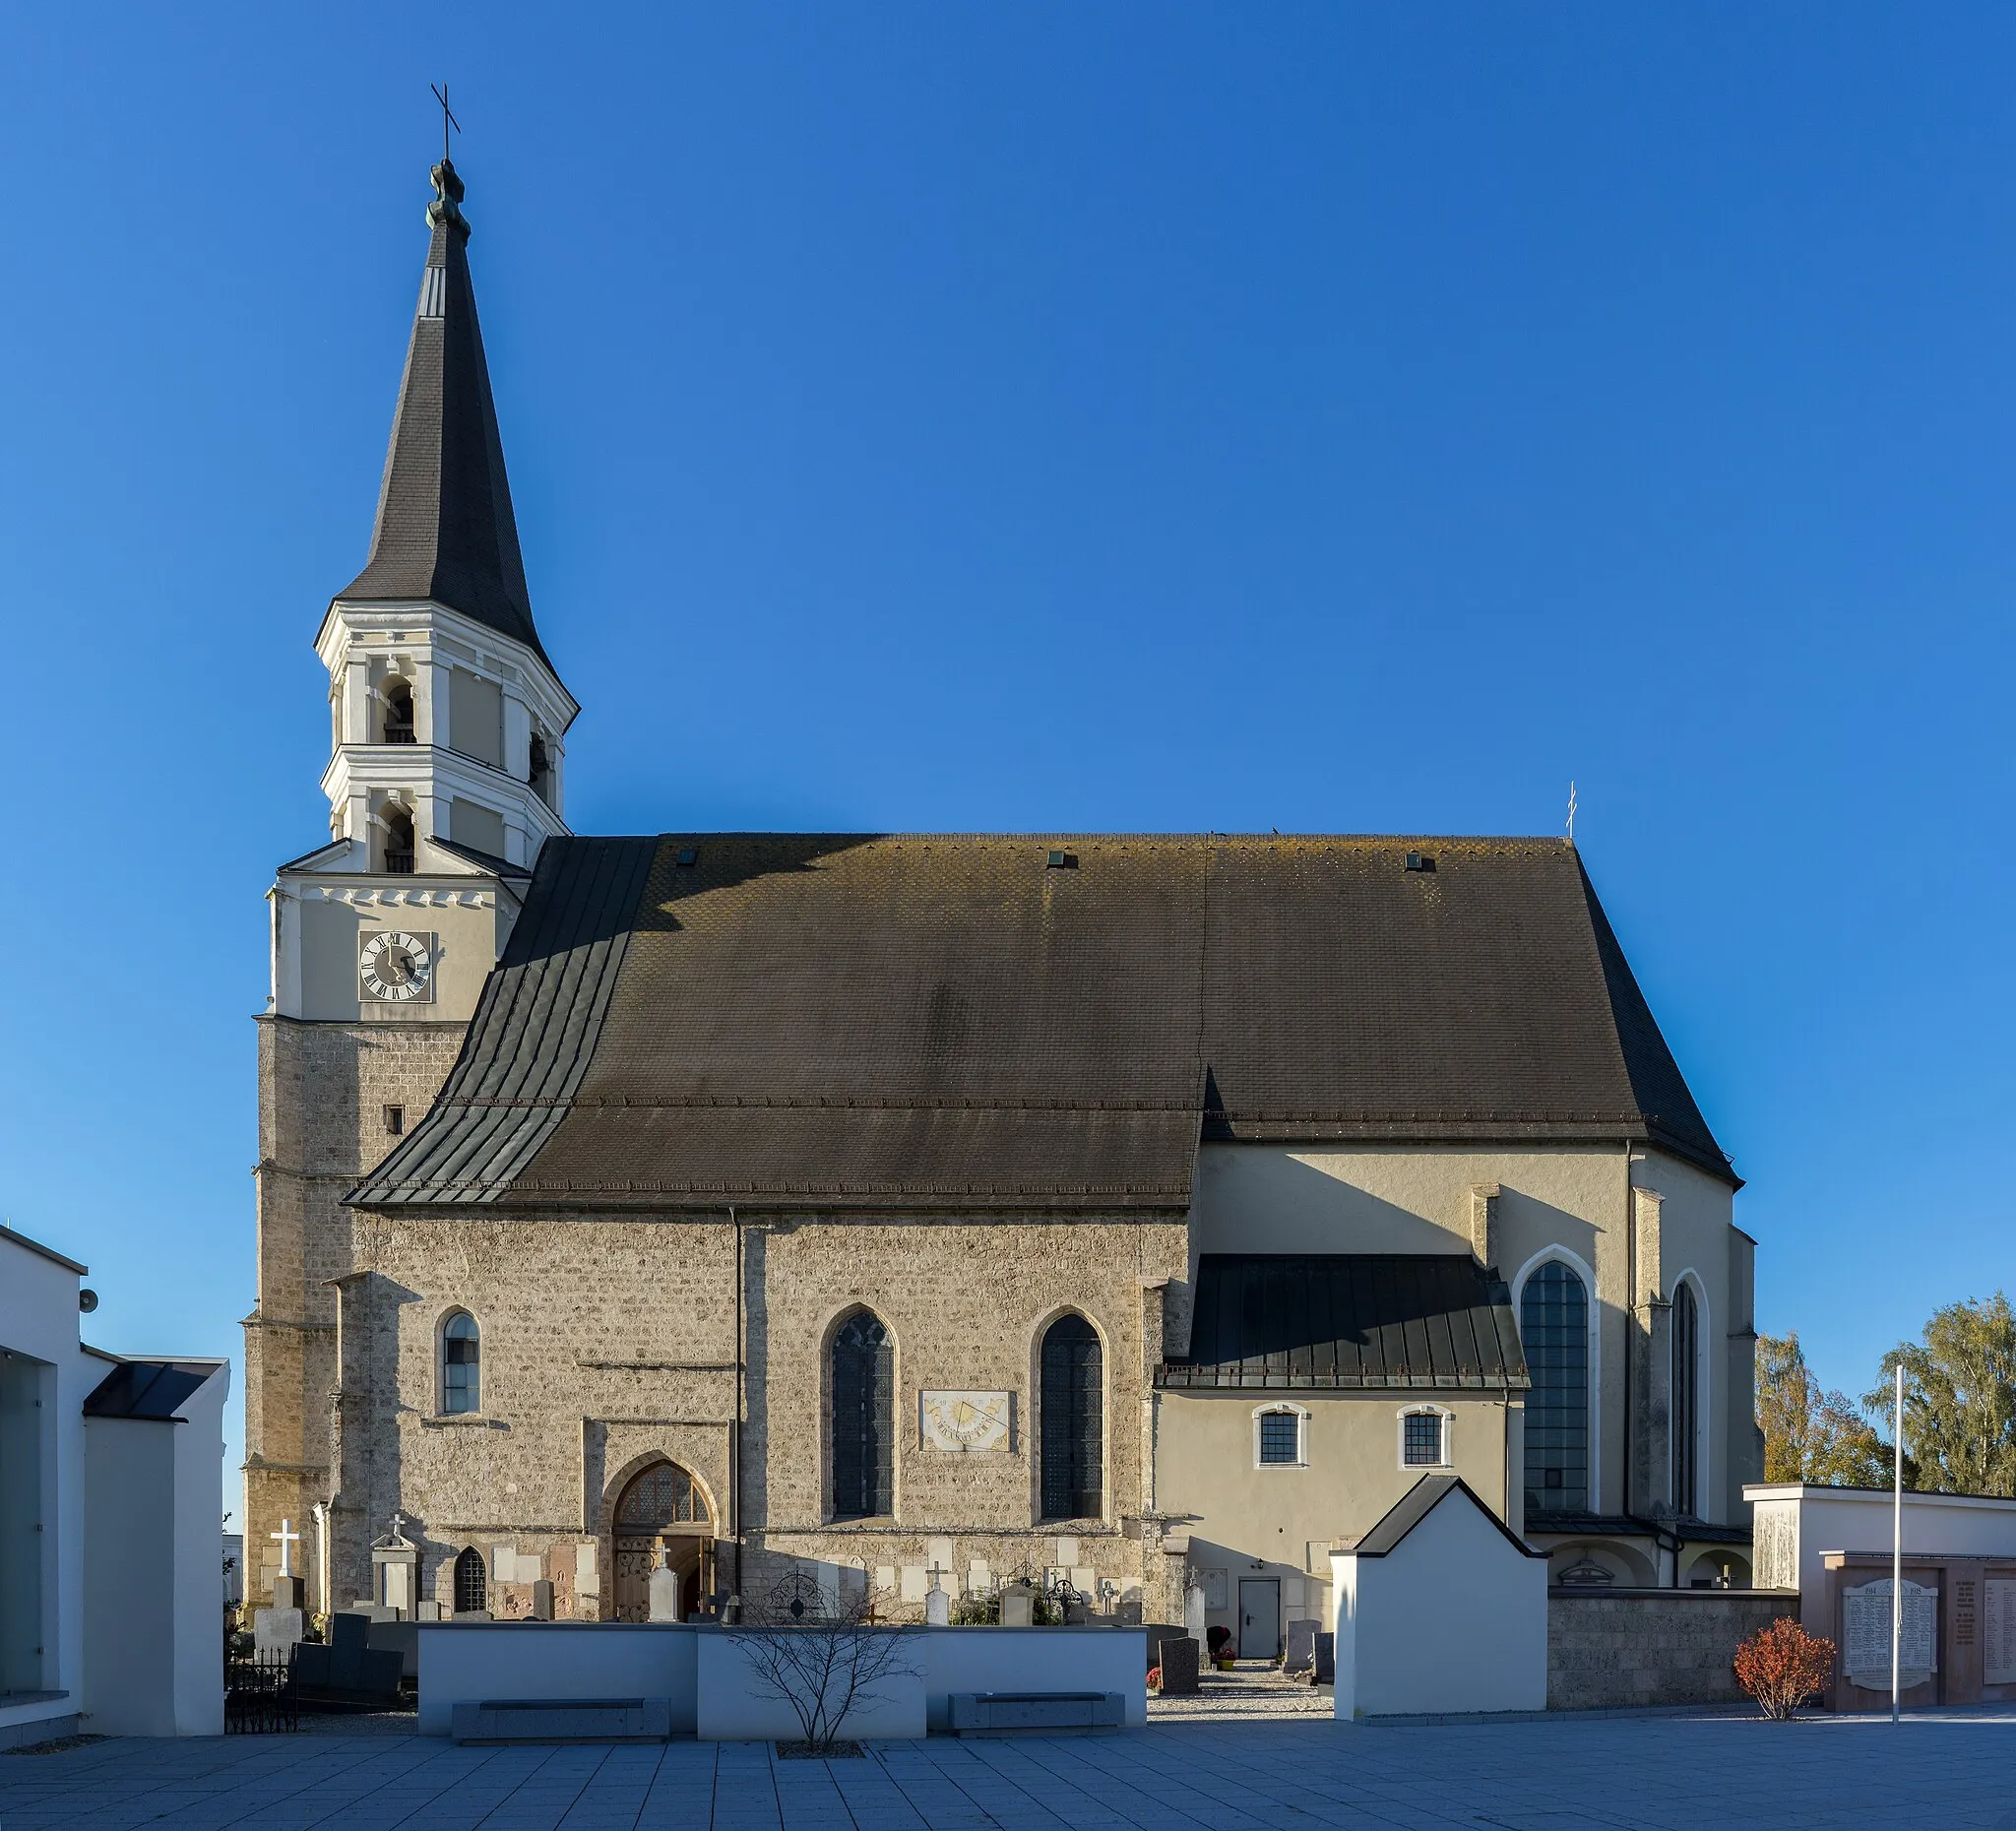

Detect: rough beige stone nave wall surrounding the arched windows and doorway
[324,1210,1183,1619]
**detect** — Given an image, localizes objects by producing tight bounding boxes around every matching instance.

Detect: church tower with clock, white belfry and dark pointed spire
[244,159,579,1610]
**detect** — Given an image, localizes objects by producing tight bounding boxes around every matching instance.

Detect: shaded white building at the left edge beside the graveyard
[0,1229,229,1748]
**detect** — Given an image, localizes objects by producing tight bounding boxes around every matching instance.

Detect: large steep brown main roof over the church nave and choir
[350,833,1735,1208]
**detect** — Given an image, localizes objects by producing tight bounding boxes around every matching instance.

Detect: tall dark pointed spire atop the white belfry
[337,158,552,667]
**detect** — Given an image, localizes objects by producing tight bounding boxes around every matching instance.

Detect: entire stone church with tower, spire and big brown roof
[244,161,1760,1654]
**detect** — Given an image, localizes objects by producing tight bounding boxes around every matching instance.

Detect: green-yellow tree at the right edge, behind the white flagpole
[1862,1291,2016,1494]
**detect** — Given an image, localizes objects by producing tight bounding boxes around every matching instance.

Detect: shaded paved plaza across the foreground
[0,1712,2016,1831]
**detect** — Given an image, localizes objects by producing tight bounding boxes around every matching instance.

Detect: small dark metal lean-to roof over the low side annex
[1158,1252,1532,1391]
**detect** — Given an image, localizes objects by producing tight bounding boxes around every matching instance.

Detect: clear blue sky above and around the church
[0,0,2016,1516]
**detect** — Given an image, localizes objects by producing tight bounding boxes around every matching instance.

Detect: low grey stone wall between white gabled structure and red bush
[1546,1589,1798,1710]
